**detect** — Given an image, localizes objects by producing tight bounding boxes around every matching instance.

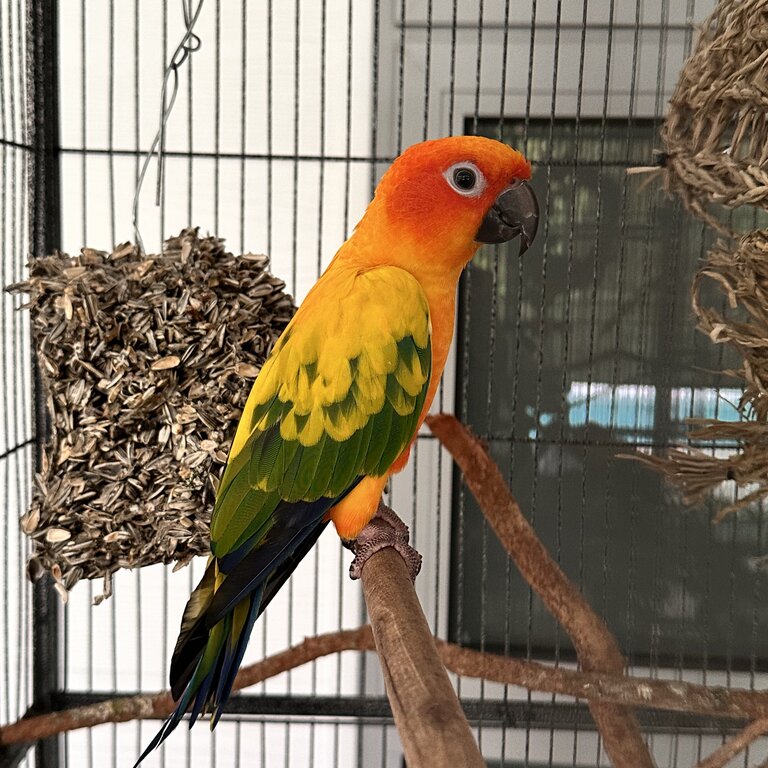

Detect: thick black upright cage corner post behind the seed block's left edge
[27,0,61,768]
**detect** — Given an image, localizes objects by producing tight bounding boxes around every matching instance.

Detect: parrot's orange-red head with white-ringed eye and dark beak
[360,136,538,276]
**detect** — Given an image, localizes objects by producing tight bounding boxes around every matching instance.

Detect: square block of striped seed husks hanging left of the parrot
[9,229,295,601]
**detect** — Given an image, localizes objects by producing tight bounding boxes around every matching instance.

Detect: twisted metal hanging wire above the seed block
[133,0,203,255]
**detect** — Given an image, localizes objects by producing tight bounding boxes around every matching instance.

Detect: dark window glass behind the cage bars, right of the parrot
[451,119,768,665]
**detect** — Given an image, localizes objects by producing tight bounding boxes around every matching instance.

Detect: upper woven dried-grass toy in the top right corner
[661,0,768,234]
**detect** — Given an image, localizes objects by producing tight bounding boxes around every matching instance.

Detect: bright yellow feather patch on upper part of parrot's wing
[231,267,429,456]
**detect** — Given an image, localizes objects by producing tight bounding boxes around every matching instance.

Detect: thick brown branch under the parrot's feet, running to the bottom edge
[362,548,485,768]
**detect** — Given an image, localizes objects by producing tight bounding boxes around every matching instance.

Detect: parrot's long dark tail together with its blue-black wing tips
[134,520,326,768]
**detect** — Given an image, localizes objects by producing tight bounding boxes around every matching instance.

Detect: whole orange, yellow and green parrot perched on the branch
[137,136,538,765]
